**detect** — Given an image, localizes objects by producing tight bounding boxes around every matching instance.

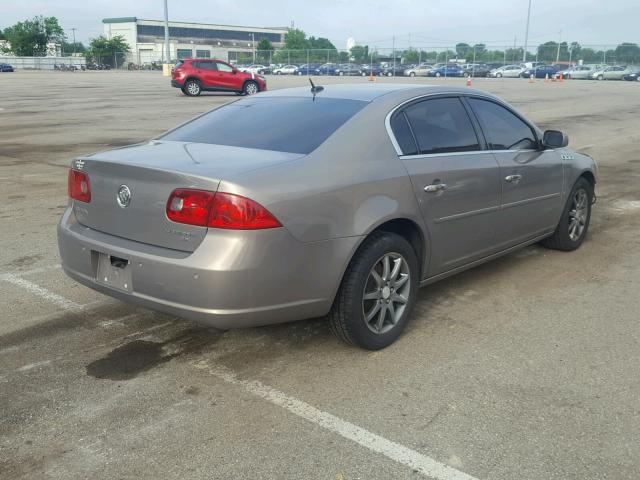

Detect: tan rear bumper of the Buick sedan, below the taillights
[58,208,360,329]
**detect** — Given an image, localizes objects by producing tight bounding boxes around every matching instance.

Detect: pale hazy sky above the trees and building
[0,0,640,49]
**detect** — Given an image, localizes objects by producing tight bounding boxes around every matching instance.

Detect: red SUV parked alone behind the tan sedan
[171,58,267,97]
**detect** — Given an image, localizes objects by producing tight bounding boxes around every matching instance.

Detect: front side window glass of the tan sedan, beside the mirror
[469,98,537,150]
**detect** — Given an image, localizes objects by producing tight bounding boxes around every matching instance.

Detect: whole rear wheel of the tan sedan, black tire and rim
[329,232,419,350]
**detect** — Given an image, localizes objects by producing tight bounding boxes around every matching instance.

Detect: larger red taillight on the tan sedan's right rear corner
[166,188,282,230]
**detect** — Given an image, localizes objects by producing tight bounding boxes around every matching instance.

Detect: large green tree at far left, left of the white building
[4,16,65,57]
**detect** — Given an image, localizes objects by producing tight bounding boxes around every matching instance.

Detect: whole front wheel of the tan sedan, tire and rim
[542,177,593,252]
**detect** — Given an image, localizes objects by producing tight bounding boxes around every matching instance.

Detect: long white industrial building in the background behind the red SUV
[102,17,287,65]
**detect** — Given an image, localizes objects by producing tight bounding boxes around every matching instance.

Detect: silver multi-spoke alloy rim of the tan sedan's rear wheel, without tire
[362,253,411,335]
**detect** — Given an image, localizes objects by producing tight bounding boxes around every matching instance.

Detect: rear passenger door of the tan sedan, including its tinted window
[391,96,500,276]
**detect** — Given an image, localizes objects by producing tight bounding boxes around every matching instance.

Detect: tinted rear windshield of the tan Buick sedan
[161,98,367,154]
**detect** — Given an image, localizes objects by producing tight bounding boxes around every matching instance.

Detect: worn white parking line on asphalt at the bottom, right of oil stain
[194,361,477,480]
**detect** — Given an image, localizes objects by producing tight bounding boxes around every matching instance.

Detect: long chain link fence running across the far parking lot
[0,42,640,71]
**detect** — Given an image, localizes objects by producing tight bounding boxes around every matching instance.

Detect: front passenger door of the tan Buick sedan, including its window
[467,96,564,248]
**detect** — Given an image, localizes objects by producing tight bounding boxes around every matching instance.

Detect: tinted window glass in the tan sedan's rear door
[405,98,480,154]
